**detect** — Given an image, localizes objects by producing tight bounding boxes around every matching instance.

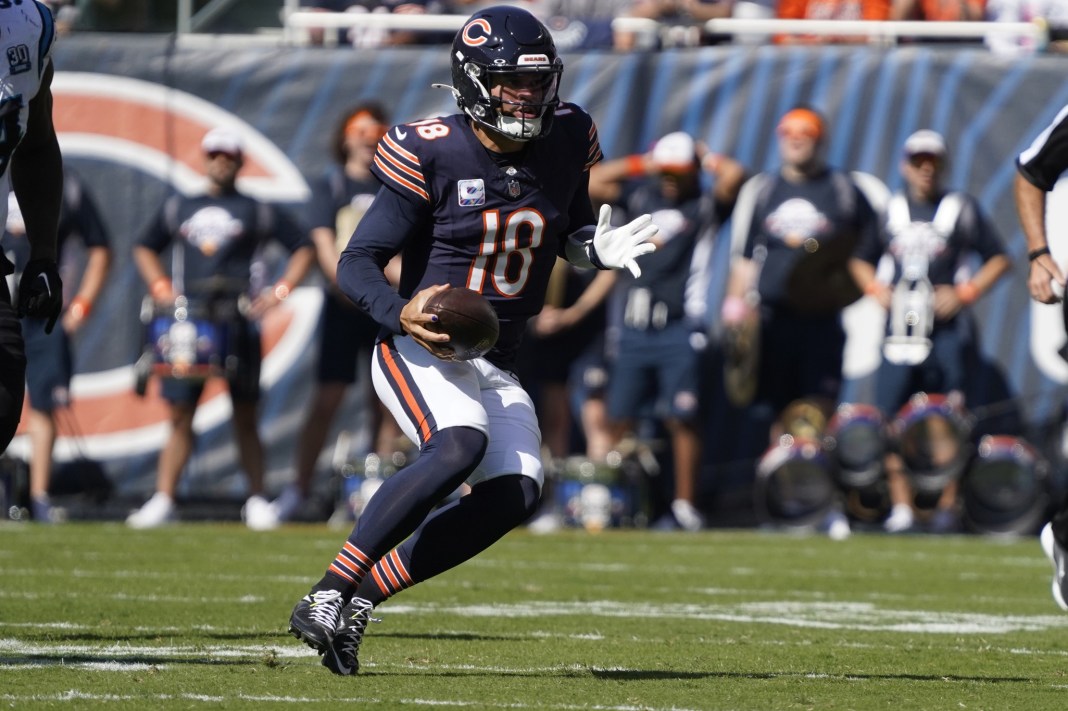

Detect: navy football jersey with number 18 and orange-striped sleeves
[339,104,601,367]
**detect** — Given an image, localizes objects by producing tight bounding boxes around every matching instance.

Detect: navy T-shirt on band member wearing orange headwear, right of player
[744,169,878,314]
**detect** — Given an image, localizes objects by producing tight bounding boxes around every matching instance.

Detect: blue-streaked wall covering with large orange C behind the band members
[29,34,1068,503]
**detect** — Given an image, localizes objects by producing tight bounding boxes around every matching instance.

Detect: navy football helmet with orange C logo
[452,5,564,141]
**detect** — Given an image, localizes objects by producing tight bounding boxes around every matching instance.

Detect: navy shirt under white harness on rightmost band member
[857,192,1005,284]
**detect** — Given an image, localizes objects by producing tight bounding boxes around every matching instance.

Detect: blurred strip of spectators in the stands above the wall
[46,0,1068,53]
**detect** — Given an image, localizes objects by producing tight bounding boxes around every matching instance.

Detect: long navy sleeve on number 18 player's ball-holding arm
[337,187,428,333]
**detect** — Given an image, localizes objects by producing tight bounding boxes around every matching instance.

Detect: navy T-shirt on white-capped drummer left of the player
[138,187,311,294]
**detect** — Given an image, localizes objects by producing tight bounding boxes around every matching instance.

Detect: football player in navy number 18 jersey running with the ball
[289,6,657,675]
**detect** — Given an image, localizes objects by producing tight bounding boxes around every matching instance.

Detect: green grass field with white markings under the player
[0,523,1068,711]
